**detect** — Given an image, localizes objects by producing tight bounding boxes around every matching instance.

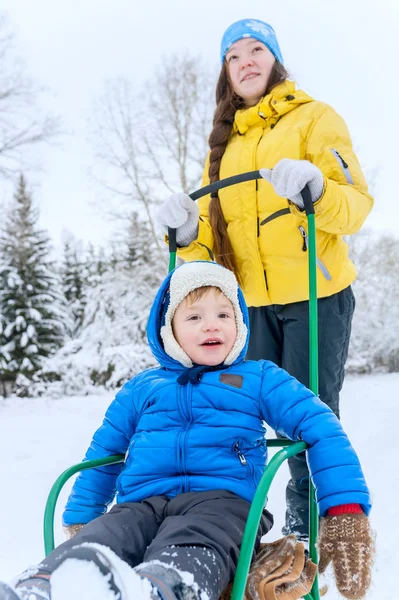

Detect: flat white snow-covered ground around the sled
[0,374,399,600]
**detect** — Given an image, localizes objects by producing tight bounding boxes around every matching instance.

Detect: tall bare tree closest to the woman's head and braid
[145,55,215,193]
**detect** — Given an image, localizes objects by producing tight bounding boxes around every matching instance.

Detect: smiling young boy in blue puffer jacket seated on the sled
[0,262,371,600]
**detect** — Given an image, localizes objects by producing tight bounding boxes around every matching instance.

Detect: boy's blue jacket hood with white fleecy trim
[147,261,249,370]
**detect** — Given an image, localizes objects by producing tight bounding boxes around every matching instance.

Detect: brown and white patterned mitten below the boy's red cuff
[318,513,374,600]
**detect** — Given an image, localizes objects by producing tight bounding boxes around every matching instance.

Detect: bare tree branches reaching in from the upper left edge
[0,15,59,178]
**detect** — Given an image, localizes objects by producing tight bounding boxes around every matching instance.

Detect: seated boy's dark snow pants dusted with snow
[40,490,273,600]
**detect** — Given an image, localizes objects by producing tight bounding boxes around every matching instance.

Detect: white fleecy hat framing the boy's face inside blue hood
[160,261,248,367]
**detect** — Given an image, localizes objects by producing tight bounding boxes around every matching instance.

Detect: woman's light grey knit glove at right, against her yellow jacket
[259,158,324,209]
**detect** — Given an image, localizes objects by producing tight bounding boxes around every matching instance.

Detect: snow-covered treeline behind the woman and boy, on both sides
[0,176,399,396]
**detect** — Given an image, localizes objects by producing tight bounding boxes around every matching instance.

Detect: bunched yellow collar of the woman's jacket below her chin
[233,80,313,135]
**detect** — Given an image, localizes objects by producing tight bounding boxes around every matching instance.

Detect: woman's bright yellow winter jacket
[178,81,373,306]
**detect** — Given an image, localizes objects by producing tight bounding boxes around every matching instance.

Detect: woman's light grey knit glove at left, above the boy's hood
[155,193,199,246]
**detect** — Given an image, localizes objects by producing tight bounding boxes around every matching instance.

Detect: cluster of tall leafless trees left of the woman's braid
[91,56,214,254]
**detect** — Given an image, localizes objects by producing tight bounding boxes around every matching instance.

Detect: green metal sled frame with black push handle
[43,175,320,600]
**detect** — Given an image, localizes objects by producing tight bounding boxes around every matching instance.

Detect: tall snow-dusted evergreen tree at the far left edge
[0,175,65,381]
